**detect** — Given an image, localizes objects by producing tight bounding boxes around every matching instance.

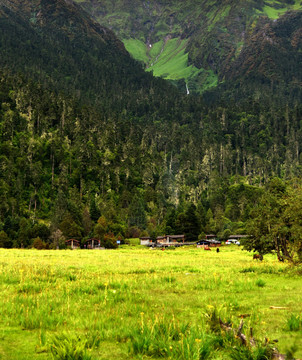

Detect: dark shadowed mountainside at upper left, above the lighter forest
[0,0,179,111]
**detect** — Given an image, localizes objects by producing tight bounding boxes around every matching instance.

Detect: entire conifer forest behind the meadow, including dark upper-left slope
[0,0,302,259]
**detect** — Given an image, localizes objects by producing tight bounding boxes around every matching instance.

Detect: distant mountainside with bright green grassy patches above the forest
[77,0,302,97]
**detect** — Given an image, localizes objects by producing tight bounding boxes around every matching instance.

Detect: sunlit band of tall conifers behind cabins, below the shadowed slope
[0,73,301,260]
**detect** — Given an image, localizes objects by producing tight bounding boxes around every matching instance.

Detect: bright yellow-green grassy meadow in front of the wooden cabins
[0,246,302,360]
